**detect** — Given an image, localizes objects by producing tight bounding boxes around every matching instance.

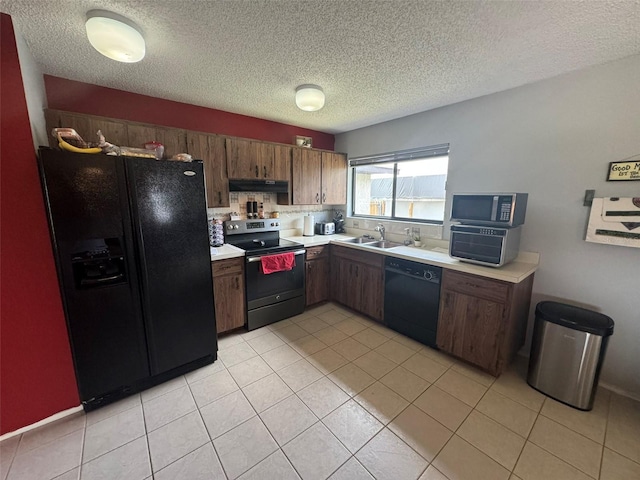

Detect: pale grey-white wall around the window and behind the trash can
[336,55,640,398]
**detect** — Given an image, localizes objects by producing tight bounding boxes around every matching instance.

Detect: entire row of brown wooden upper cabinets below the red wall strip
[45,110,340,207]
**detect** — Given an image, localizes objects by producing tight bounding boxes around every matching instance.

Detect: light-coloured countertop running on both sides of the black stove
[211,234,540,283]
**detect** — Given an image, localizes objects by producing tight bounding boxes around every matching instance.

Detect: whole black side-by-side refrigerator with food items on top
[38,147,217,410]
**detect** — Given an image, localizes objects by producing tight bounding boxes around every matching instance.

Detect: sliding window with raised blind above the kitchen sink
[349,144,449,223]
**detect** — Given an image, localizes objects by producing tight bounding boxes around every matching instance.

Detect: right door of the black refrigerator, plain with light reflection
[125,158,217,375]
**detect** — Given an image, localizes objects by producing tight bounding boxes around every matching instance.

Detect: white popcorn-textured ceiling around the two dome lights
[0,0,640,133]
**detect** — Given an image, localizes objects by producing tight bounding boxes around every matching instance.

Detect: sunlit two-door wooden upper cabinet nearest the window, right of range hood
[291,148,347,205]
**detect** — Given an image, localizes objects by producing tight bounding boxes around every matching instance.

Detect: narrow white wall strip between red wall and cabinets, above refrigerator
[14,24,49,149]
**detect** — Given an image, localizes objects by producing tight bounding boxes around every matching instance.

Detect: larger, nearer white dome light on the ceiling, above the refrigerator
[85,10,145,63]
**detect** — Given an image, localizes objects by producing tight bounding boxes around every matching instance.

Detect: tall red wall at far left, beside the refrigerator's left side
[0,14,80,434]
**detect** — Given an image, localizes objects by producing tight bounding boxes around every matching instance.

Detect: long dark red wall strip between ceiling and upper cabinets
[44,75,334,150]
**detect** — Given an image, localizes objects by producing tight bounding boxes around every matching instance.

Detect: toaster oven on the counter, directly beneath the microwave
[449,225,522,267]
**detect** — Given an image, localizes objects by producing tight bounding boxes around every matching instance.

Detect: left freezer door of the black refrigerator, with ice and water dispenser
[39,149,149,402]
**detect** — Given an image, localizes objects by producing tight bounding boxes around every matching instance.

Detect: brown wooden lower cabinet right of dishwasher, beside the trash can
[437,269,533,376]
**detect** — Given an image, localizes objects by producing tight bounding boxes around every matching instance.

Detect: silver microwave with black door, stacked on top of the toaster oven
[451,193,529,227]
